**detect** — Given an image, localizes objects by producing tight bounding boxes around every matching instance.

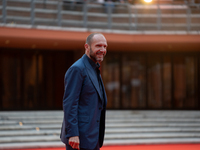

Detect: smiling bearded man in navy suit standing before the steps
[61,33,107,150]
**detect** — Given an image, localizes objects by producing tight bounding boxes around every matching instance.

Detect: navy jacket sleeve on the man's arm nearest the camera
[63,67,83,138]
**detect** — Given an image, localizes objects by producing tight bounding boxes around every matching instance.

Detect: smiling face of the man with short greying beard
[85,34,107,63]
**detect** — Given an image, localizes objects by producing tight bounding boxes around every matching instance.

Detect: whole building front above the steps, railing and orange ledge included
[0,0,200,110]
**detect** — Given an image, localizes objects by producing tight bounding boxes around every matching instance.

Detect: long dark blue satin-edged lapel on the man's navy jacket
[83,55,103,100]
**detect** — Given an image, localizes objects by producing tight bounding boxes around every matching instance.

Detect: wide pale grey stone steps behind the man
[0,110,200,149]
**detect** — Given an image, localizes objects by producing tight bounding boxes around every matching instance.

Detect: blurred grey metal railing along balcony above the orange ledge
[0,0,200,31]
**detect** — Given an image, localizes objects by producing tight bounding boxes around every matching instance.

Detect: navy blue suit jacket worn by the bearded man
[61,54,107,149]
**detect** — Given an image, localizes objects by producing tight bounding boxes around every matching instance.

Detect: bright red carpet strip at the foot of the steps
[8,143,200,150]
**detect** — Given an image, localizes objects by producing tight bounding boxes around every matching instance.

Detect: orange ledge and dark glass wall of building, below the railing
[0,27,200,110]
